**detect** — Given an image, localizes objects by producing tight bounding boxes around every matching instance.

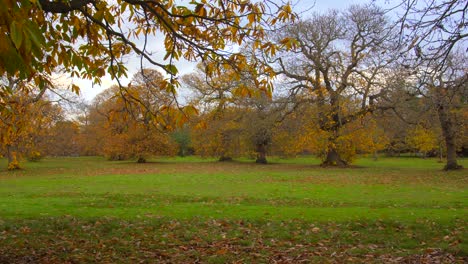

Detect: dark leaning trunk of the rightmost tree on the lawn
[437,104,463,170]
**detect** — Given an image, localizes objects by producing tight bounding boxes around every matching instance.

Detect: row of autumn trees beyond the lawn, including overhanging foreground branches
[0,0,468,169]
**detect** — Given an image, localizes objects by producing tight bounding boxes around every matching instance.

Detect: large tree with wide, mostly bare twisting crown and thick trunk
[274,5,395,166]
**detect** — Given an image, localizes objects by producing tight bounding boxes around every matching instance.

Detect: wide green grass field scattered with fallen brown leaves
[0,157,468,263]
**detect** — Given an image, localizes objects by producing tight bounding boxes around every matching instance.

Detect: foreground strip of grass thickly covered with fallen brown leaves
[0,219,468,263]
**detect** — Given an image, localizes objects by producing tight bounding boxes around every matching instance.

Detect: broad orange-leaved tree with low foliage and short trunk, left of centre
[92,69,181,163]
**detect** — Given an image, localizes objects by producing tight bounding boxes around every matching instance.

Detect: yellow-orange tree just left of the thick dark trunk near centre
[183,64,250,161]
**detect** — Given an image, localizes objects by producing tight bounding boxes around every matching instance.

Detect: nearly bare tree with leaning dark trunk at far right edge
[399,0,468,170]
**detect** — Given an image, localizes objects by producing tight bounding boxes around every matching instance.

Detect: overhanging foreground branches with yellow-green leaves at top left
[0,0,294,103]
